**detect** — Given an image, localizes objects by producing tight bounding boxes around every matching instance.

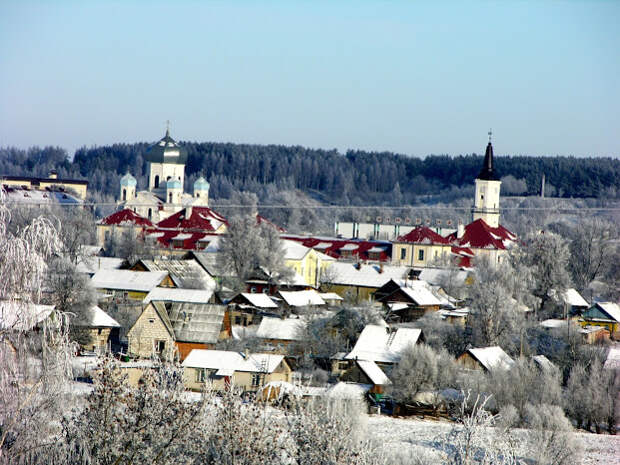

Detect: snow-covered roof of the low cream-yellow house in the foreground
[182,349,284,376]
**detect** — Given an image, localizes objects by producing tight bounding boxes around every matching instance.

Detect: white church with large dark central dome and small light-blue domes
[119,129,209,223]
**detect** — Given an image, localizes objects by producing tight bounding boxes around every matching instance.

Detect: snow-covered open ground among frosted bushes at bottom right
[368,415,620,465]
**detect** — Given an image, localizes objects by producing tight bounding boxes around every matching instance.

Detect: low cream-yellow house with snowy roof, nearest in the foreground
[182,349,292,391]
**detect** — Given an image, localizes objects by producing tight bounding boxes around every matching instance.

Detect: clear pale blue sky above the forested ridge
[0,0,620,156]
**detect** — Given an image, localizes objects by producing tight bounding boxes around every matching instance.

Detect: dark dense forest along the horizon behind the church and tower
[0,142,620,205]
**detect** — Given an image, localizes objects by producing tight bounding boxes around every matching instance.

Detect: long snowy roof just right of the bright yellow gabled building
[323,261,409,288]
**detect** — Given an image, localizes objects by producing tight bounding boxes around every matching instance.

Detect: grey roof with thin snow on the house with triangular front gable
[166,302,226,344]
